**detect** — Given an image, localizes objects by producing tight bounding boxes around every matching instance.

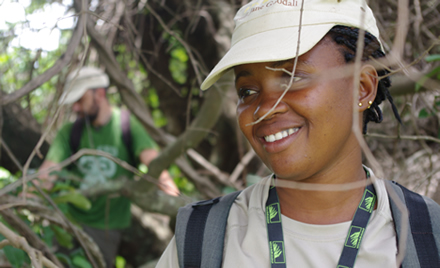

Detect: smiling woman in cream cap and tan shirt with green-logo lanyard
[158,0,440,267]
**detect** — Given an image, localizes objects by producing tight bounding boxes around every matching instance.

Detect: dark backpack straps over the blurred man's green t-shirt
[69,110,134,165]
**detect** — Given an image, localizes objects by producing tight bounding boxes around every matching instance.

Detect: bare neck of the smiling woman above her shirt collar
[277,166,366,224]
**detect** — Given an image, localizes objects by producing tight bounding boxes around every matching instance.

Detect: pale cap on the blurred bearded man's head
[59,67,110,105]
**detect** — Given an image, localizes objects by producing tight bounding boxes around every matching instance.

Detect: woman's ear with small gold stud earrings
[359,64,379,112]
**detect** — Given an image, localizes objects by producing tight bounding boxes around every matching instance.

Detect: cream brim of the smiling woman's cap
[201,24,335,90]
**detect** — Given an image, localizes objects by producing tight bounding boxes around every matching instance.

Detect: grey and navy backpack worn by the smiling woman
[175,181,440,268]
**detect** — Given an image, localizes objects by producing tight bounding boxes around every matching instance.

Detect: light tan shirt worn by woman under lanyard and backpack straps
[156,174,397,268]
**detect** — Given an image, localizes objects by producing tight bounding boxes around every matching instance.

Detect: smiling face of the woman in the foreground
[234,38,360,181]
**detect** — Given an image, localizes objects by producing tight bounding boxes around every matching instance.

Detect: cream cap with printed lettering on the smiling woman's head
[201,0,379,90]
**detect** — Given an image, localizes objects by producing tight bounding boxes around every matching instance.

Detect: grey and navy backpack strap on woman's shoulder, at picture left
[175,191,241,268]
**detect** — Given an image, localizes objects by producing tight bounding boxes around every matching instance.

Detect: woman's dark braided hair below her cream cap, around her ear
[329,25,402,134]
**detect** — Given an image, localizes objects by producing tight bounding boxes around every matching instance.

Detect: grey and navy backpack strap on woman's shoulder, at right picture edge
[388,182,440,268]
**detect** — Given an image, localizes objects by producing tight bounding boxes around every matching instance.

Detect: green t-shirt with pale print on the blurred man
[46,108,157,229]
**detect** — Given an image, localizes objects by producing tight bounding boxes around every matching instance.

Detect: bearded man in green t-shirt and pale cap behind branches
[40,67,179,267]
